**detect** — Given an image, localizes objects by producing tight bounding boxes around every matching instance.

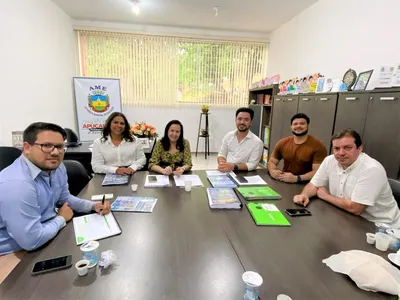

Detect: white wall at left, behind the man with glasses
[0,0,77,145]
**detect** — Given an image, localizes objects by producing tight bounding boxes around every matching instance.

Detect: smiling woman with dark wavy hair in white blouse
[92,112,146,175]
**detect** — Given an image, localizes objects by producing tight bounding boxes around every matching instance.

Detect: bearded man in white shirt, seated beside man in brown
[217,107,264,172]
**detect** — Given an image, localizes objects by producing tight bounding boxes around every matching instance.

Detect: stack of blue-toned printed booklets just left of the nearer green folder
[207,188,242,209]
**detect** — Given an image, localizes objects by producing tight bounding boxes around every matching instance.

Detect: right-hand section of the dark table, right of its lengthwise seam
[196,170,397,300]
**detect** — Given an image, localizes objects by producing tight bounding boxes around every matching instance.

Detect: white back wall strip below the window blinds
[123,105,236,152]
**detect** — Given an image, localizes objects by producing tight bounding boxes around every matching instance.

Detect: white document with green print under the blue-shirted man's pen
[72,213,121,245]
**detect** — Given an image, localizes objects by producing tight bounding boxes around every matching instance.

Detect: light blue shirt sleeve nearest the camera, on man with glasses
[0,180,65,250]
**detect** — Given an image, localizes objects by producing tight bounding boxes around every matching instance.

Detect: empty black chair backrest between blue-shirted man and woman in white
[64,160,91,196]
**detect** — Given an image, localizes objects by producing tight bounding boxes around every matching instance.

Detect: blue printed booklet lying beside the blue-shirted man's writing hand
[111,196,157,212]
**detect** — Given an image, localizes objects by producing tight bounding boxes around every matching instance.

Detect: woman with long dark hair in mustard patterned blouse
[149,120,192,176]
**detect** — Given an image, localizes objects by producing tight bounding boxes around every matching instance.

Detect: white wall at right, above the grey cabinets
[268,0,400,89]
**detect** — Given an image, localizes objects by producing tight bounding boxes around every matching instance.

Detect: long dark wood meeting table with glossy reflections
[0,170,396,300]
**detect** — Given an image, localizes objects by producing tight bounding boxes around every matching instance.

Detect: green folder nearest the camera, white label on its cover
[246,202,290,226]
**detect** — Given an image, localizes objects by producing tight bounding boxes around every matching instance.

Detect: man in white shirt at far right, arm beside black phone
[293,129,400,228]
